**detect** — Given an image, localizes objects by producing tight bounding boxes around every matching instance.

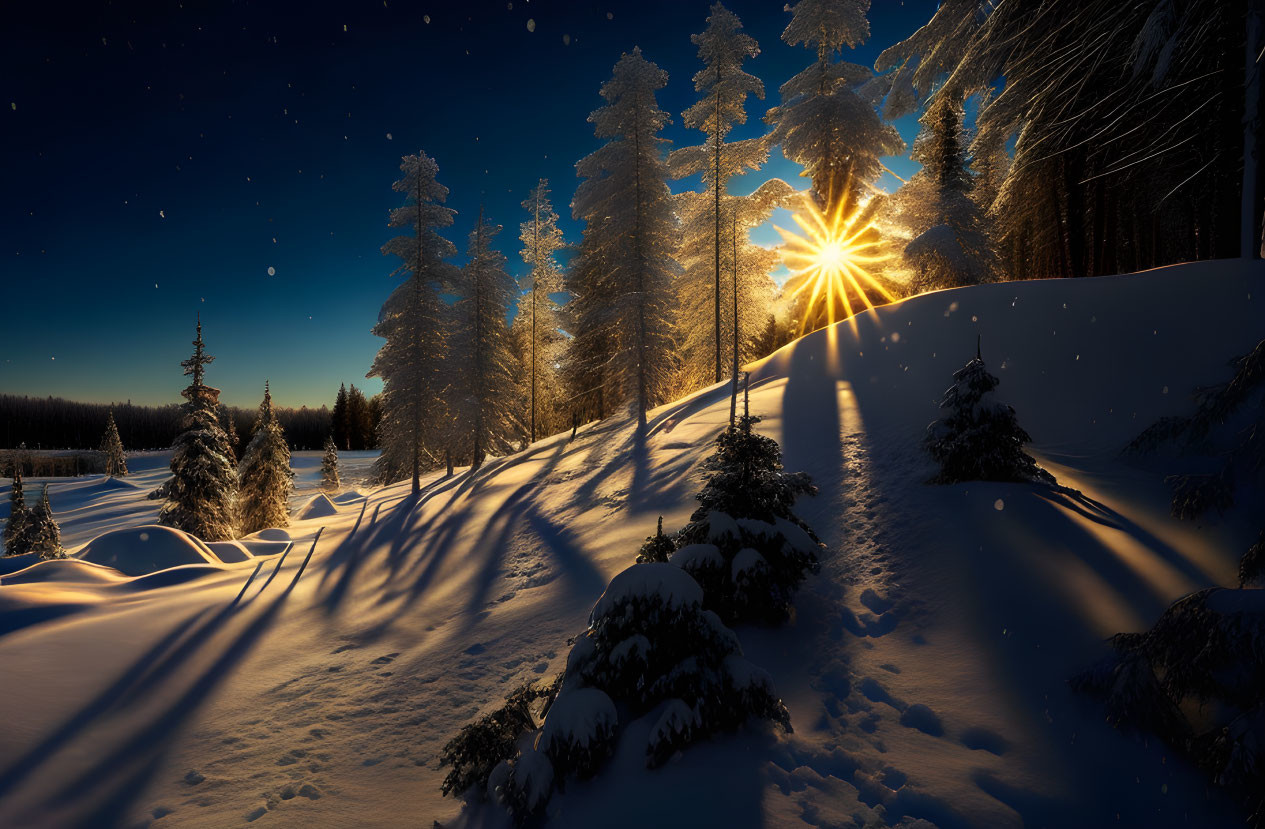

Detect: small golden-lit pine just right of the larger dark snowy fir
[238,382,295,535]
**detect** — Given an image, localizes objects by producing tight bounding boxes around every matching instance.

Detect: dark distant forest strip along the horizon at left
[0,386,376,452]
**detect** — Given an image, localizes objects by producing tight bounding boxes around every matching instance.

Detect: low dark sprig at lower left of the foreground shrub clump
[439,677,560,795]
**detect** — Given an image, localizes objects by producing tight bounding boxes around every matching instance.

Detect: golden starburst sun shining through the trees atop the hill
[778,187,896,334]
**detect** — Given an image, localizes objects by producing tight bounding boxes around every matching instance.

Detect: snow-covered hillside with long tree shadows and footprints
[0,262,1265,828]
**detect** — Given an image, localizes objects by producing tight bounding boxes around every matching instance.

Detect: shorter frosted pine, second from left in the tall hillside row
[449,208,521,468]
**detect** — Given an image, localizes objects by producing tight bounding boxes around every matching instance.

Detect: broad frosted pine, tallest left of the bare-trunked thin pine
[568,48,677,423]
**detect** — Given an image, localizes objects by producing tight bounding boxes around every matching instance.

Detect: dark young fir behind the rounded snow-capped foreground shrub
[672,414,821,624]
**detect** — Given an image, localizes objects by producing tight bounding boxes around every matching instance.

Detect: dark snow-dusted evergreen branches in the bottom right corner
[1073,587,1265,826]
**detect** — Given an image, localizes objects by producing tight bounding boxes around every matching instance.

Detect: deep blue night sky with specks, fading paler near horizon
[0,0,936,406]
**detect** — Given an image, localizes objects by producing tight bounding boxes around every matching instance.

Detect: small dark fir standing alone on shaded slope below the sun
[925,344,1055,483]
